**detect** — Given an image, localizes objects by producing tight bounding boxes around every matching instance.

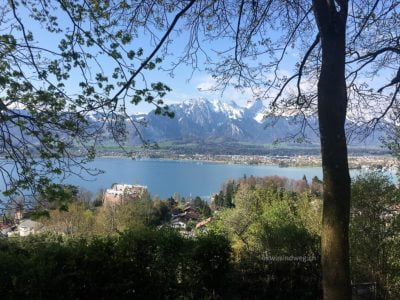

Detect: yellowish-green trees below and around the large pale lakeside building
[26,185,212,236]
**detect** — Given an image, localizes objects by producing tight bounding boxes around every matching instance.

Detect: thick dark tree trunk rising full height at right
[314,1,351,300]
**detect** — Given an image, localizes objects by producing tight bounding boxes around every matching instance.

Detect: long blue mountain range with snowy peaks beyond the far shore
[126,98,383,147]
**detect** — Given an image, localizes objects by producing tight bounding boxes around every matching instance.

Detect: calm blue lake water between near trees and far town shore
[60,158,376,198]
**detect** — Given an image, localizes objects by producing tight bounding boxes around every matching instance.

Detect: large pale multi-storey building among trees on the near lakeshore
[103,184,147,204]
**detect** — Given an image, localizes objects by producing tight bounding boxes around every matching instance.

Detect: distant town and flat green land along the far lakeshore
[87,141,400,172]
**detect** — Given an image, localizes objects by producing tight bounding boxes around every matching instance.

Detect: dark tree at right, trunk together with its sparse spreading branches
[145,0,400,299]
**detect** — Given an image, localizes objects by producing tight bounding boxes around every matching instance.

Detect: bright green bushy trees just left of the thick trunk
[214,177,321,255]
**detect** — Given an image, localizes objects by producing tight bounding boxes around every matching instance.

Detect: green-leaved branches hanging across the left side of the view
[0,0,173,207]
